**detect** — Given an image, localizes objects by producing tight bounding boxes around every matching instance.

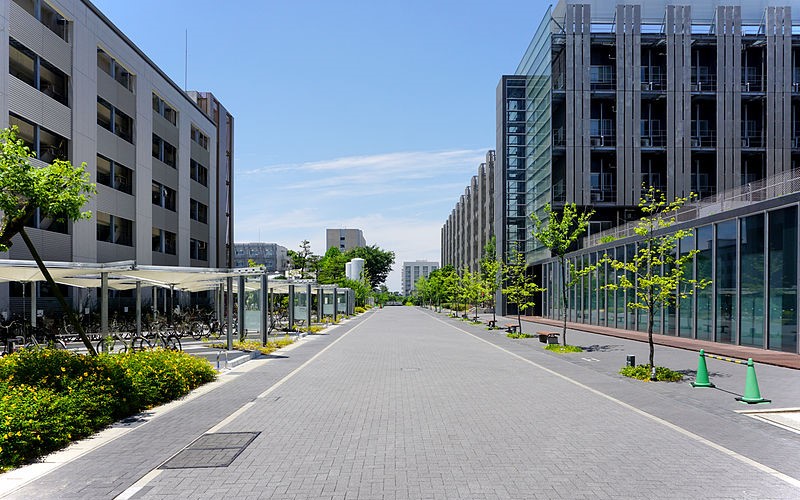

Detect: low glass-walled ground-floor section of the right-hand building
[541,188,800,353]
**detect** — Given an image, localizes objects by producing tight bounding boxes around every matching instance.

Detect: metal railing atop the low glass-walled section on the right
[583,169,800,248]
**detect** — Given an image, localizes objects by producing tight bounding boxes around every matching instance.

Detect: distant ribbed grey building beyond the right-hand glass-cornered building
[441,150,495,271]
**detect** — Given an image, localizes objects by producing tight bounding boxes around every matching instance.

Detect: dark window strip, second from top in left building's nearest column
[8,38,69,106]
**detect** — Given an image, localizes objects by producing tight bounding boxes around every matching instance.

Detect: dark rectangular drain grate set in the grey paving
[159,432,261,469]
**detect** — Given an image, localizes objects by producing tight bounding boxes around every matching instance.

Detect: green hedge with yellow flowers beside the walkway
[0,349,216,471]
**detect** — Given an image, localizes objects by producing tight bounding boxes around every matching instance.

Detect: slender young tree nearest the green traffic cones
[601,186,711,380]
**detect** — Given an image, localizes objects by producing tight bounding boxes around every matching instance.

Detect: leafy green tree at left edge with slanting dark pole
[0,127,97,355]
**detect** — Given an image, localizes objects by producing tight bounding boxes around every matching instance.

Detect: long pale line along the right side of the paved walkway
[432,316,800,488]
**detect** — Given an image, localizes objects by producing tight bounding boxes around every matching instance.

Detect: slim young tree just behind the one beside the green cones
[531,203,594,345]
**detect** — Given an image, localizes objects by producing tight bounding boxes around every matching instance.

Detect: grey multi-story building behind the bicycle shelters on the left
[0,0,233,312]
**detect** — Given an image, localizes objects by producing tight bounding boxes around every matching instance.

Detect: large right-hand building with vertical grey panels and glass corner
[495,0,800,352]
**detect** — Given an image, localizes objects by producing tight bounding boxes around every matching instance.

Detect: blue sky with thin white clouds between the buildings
[93,0,550,290]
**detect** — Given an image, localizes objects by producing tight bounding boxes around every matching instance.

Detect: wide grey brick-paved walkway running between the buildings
[0,307,800,499]
